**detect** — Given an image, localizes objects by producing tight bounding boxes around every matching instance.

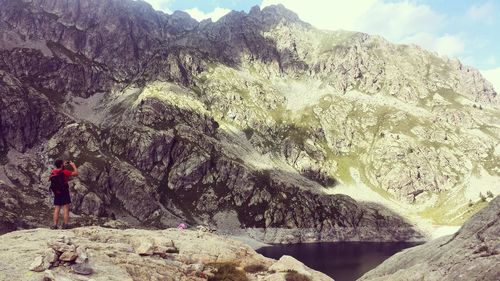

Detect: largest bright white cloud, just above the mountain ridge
[261,0,465,57]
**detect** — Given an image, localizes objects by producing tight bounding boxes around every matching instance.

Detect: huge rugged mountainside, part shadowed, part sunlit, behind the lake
[0,0,500,242]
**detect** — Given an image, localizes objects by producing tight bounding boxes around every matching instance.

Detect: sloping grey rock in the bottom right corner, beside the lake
[359,196,500,281]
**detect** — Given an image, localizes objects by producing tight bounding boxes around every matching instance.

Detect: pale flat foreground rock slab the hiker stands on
[0,227,332,281]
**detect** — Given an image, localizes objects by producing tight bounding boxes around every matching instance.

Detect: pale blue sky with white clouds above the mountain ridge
[145,0,500,93]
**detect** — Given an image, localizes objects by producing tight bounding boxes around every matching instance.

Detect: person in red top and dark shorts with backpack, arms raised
[50,160,78,229]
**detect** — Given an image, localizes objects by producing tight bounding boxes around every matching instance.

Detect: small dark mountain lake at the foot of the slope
[257,242,420,281]
